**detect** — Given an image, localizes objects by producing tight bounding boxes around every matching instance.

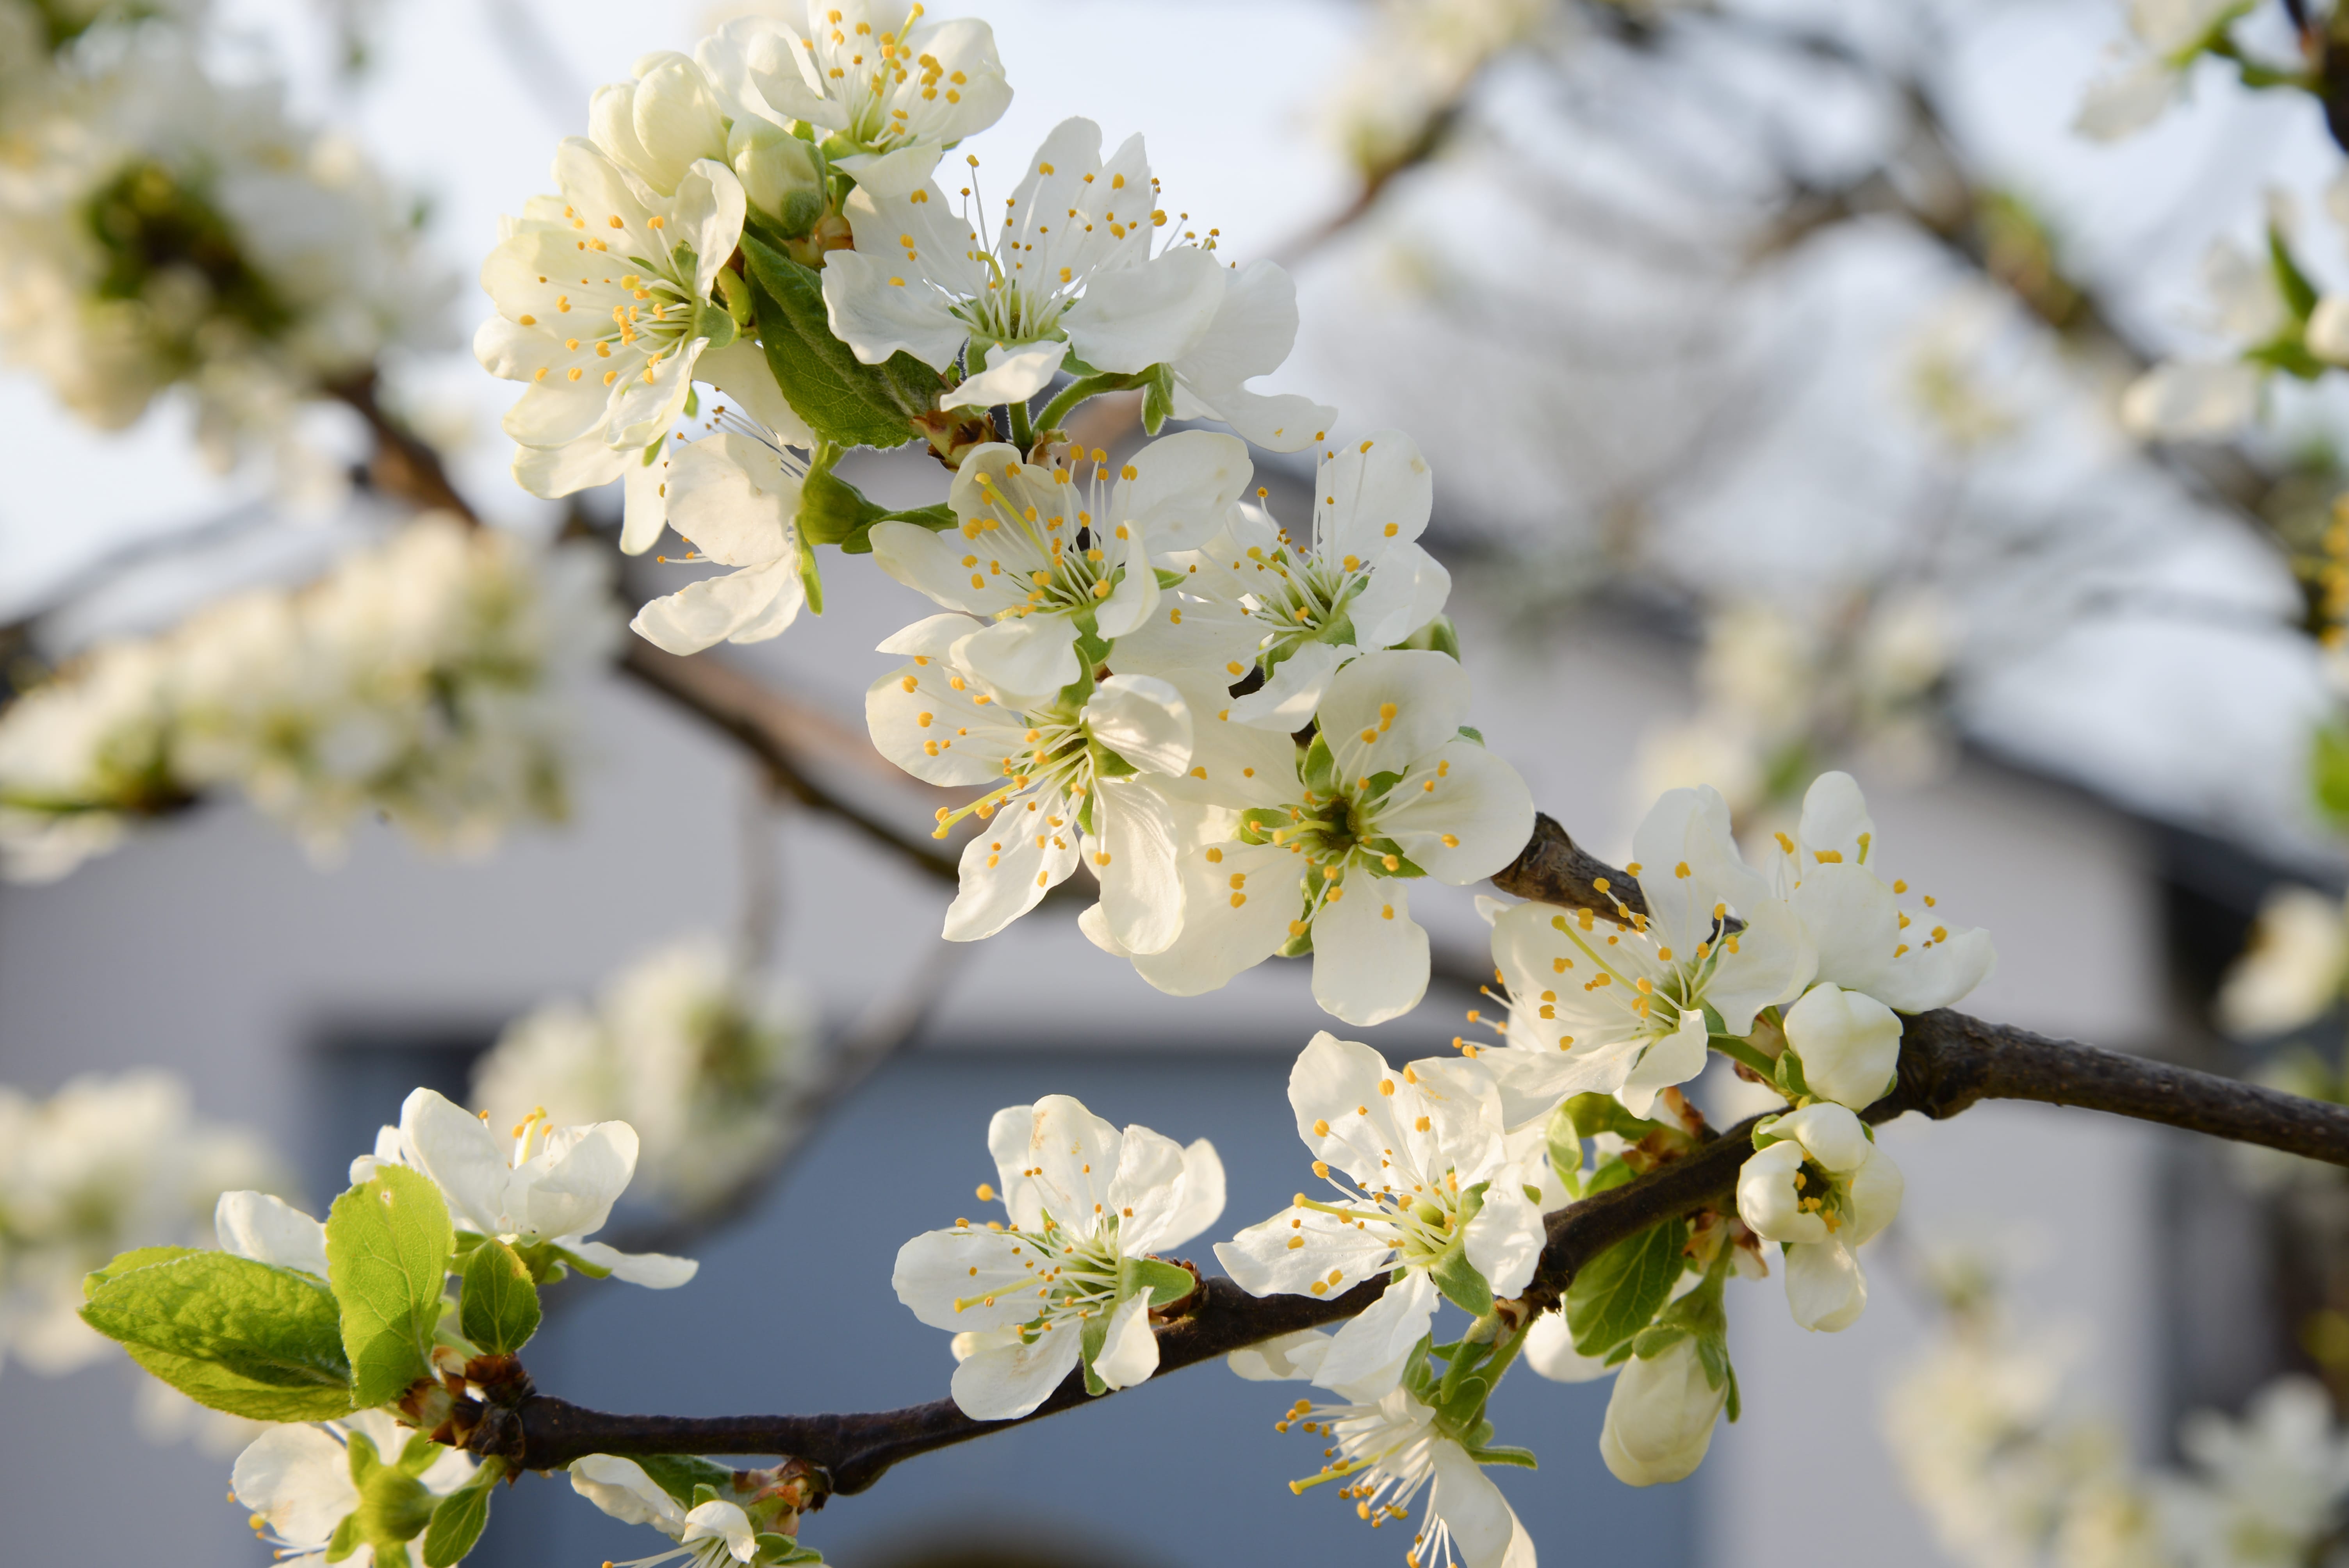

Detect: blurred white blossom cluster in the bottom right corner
[1884,1258,2349,1568]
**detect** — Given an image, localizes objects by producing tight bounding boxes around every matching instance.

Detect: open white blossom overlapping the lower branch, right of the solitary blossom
[1214,1030,1543,1387]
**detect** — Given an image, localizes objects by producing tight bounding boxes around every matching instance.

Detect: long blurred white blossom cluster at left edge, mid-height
[0,517,618,880]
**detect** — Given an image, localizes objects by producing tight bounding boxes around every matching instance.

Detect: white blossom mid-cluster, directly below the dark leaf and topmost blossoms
[872,429,1250,697]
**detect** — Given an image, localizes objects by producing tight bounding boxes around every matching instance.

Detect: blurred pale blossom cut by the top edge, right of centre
[1322,0,1559,181]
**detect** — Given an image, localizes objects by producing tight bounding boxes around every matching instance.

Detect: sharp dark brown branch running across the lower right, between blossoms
[481,817,2349,1493]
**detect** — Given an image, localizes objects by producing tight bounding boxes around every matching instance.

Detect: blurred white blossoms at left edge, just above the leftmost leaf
[0,1070,284,1376]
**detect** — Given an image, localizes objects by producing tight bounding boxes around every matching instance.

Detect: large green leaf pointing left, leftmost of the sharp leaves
[82,1249,350,1420]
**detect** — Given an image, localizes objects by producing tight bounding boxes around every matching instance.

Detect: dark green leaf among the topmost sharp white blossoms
[742,235,944,446]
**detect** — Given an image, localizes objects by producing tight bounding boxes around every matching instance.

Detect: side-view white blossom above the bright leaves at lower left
[350,1089,700,1291]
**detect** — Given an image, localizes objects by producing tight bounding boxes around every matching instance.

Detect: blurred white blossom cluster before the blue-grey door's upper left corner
[472,937,815,1213]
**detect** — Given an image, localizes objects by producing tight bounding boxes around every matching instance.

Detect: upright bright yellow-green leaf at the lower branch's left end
[326,1164,456,1408]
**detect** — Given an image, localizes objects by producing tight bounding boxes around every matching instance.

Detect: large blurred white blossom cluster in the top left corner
[0,0,453,465]
